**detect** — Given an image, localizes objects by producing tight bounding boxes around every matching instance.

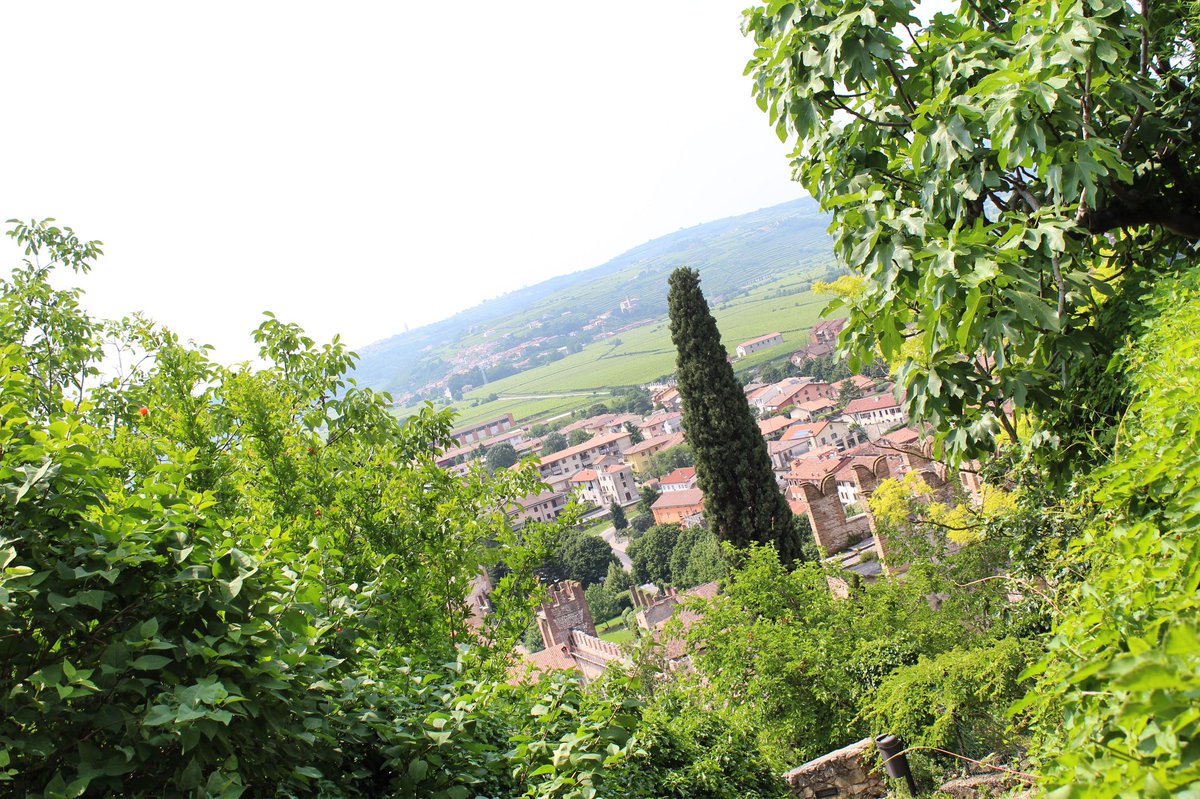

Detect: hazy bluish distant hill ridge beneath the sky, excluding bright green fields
[355,198,833,400]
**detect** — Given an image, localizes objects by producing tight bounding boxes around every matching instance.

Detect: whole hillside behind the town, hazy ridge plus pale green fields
[356,198,833,400]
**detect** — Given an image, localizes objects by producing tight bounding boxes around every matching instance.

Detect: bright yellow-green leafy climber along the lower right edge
[1024,268,1200,799]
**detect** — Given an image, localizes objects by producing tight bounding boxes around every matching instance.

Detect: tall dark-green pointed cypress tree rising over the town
[667,269,800,563]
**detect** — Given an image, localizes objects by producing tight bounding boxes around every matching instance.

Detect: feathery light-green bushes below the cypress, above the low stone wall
[688,547,1032,769]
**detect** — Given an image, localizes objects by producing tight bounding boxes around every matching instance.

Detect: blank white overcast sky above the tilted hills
[0,0,802,361]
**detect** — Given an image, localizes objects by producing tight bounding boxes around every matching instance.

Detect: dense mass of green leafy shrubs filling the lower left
[0,226,657,799]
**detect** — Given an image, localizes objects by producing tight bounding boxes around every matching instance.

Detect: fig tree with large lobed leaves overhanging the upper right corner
[744,0,1200,460]
